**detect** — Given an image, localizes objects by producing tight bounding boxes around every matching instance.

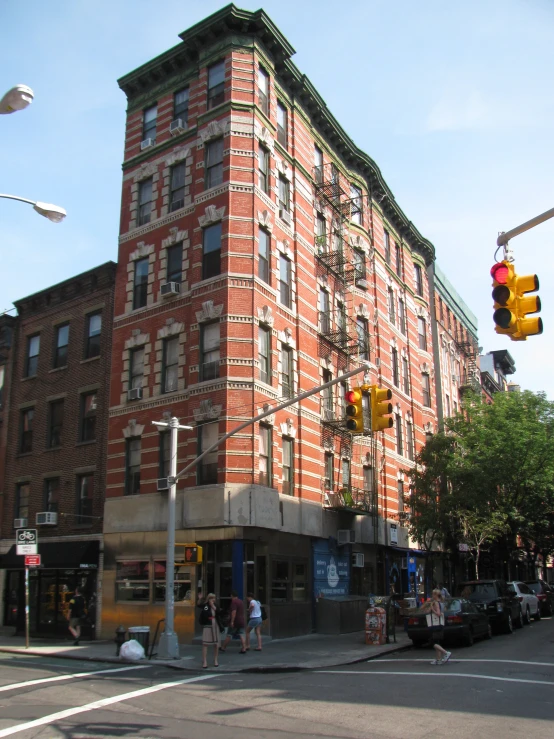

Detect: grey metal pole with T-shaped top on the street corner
[152,416,193,659]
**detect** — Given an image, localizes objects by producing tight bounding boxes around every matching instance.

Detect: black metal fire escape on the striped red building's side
[314,163,377,523]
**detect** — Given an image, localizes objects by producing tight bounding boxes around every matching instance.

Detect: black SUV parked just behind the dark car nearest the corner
[458,580,523,634]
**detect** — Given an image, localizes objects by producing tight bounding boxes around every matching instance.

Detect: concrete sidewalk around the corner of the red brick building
[0,629,412,672]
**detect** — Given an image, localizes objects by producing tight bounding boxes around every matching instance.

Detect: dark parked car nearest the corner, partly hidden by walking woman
[406,598,492,647]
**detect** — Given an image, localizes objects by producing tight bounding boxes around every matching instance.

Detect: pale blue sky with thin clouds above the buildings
[0,0,554,399]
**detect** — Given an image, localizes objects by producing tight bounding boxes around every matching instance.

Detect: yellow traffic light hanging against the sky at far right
[491,260,542,341]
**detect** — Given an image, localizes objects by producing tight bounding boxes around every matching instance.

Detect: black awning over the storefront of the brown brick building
[0,539,100,570]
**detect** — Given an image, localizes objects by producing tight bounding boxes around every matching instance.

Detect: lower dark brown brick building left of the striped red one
[0,262,116,638]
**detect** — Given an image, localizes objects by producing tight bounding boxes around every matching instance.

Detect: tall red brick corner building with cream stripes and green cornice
[103,5,437,640]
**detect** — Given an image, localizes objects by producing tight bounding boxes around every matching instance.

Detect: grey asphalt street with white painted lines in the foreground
[0,619,554,739]
